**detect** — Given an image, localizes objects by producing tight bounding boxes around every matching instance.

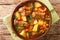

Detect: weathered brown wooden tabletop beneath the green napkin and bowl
[0,0,60,40]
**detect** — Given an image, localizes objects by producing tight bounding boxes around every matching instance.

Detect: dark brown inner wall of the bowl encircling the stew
[11,1,51,40]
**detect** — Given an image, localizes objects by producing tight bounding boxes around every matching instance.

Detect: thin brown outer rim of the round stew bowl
[10,0,52,40]
